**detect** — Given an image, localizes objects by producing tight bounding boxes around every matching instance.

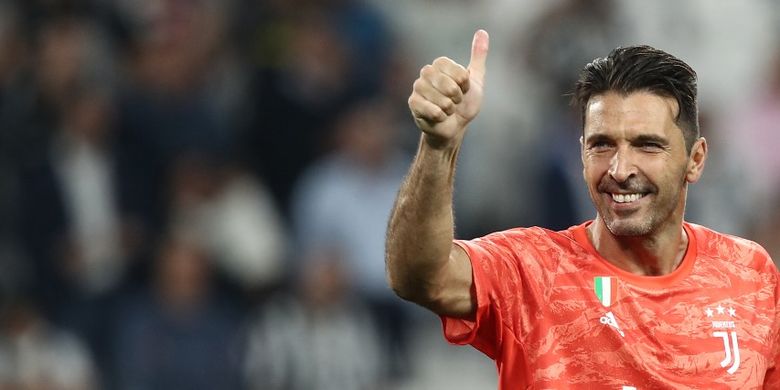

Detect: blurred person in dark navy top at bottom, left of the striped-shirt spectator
[108,230,240,390]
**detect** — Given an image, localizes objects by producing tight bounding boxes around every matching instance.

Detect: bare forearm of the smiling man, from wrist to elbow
[386,136,459,304]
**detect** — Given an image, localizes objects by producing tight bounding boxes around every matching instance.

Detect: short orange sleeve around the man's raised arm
[441,229,539,359]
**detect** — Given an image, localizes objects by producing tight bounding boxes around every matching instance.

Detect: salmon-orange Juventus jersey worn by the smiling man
[442,222,780,390]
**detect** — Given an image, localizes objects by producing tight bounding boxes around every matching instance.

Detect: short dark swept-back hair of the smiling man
[572,45,700,153]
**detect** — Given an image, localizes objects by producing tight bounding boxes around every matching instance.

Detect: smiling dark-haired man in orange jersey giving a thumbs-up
[387,30,780,389]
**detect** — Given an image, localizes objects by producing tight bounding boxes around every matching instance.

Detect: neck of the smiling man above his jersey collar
[587,217,688,276]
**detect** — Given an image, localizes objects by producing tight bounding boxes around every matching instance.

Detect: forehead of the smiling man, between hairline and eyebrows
[583,91,682,138]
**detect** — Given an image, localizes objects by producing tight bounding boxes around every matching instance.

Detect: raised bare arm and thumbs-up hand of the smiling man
[386,30,489,317]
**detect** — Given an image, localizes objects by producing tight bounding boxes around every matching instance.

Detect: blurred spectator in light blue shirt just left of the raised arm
[293,101,409,377]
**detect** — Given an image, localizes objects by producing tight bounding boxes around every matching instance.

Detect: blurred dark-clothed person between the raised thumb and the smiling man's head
[517,0,624,229]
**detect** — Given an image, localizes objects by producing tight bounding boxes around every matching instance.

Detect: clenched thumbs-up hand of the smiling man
[409,30,490,148]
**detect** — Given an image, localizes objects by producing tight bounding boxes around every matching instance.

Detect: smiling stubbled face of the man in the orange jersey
[582,92,706,236]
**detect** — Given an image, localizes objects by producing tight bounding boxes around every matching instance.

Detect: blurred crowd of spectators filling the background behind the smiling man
[0,0,780,390]
